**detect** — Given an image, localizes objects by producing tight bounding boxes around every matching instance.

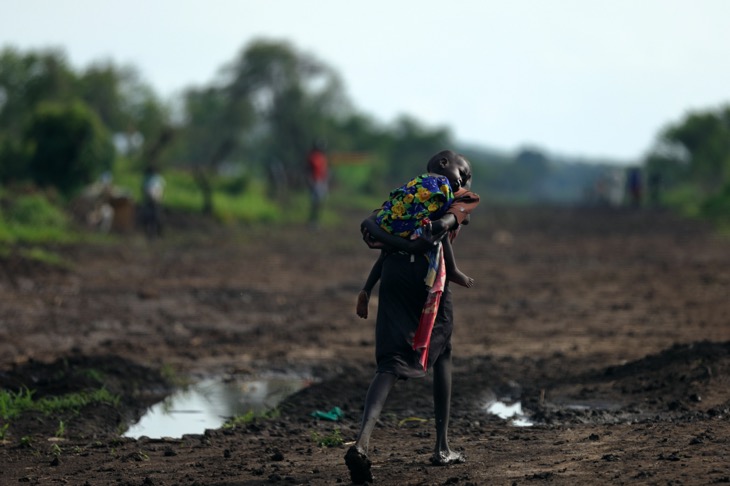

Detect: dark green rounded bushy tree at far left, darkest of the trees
[23,102,114,196]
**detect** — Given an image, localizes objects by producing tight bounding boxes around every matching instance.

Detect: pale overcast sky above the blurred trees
[0,0,730,161]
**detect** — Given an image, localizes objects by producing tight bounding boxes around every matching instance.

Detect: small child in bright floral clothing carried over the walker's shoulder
[356,150,479,319]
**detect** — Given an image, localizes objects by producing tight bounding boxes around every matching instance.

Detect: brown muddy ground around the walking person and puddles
[0,207,730,486]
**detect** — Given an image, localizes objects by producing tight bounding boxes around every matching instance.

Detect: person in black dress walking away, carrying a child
[345,152,478,484]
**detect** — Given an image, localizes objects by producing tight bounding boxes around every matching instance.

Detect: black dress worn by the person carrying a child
[375,253,453,378]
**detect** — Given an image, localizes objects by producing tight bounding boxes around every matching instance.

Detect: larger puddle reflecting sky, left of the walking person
[124,376,312,439]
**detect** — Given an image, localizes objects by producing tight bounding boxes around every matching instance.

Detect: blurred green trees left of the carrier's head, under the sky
[0,40,453,211]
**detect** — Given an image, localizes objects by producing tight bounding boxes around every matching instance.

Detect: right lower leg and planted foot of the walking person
[431,351,464,466]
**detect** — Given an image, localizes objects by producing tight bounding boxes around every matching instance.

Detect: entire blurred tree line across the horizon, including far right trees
[0,39,730,218]
